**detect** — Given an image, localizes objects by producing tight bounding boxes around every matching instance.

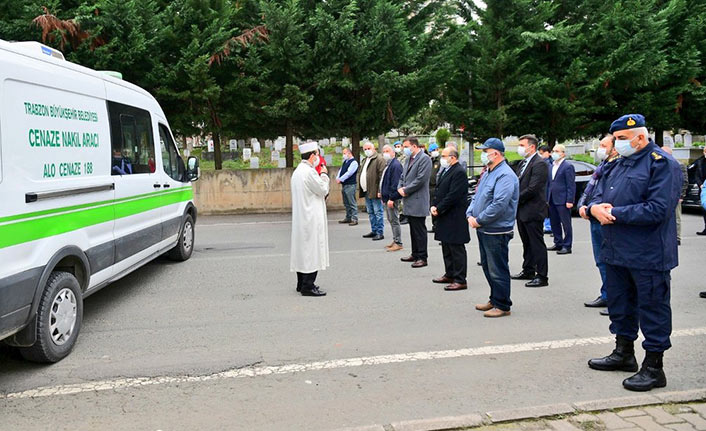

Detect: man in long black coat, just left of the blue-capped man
[431,148,471,291]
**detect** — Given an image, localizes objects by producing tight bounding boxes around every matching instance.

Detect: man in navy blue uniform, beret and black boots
[588,114,681,391]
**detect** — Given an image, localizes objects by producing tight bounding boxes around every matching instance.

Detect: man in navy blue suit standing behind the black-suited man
[547,144,576,254]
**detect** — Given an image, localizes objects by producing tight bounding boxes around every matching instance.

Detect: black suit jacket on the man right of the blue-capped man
[517,154,549,222]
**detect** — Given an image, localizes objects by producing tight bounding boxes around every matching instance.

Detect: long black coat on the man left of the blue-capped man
[432,163,471,244]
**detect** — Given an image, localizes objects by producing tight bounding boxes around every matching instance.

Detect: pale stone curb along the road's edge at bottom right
[338,389,706,431]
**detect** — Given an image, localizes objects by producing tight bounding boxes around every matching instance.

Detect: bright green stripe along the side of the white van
[0,187,193,248]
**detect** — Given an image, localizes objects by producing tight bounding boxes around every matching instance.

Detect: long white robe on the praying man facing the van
[289,160,330,274]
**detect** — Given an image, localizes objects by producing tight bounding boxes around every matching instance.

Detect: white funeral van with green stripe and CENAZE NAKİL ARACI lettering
[0,40,199,362]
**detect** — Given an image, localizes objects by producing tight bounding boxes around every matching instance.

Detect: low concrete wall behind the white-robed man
[194,167,363,215]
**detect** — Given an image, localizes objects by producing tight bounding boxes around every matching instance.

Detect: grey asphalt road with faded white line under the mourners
[0,208,706,431]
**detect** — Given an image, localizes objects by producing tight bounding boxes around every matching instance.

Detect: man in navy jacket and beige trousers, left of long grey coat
[380,145,402,251]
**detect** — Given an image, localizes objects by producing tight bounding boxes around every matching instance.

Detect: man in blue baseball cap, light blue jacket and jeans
[466,138,520,317]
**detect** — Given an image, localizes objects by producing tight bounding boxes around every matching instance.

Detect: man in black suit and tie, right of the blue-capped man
[512,135,549,287]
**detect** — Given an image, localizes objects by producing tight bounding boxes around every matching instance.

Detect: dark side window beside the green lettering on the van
[108,101,156,175]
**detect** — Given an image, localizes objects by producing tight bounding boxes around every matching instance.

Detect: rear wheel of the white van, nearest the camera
[20,271,83,363]
